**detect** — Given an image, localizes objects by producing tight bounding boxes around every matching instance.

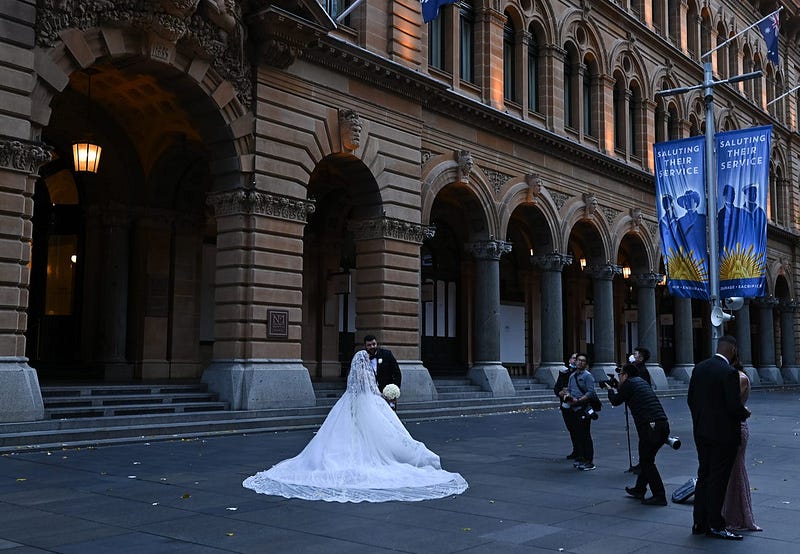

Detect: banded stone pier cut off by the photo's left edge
[0,137,50,422]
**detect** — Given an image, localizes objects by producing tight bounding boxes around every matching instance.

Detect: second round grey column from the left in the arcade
[531,252,572,387]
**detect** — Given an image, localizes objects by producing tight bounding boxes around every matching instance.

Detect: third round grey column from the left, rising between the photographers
[586,264,622,380]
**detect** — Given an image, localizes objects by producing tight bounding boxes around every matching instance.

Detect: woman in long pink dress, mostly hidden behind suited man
[722,372,761,531]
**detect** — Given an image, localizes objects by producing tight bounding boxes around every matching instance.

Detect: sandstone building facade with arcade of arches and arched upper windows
[0,0,800,421]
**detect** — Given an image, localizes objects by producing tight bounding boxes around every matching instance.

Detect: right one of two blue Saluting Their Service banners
[716,126,772,298]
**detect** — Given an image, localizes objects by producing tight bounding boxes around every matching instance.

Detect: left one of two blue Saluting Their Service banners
[653,136,708,300]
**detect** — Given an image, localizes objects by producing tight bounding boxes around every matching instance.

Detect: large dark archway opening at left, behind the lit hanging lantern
[26,57,241,381]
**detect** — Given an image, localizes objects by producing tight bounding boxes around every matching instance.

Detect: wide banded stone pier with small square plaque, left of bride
[202,188,316,410]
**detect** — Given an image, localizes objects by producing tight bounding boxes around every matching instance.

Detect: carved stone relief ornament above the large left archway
[35,0,252,106]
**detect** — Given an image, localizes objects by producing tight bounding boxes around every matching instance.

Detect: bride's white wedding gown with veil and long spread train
[242,350,467,502]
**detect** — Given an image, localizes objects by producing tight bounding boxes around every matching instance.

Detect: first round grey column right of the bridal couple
[468,240,516,396]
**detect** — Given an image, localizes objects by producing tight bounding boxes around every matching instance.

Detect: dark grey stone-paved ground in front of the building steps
[0,389,800,554]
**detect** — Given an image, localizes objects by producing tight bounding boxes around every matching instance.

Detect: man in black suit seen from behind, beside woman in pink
[687,335,750,540]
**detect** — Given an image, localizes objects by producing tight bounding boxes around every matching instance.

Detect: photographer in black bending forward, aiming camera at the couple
[601,364,669,506]
